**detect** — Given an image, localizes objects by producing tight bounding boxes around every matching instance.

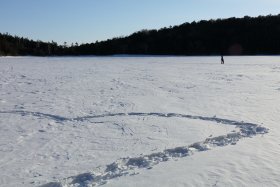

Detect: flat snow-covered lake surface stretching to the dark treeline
[0,56,280,187]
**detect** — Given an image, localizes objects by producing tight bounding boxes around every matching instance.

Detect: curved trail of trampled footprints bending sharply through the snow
[0,110,268,187]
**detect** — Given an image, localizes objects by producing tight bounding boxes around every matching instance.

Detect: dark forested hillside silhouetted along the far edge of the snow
[0,14,280,56]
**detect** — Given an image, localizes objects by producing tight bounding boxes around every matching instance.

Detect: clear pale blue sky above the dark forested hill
[0,0,280,44]
